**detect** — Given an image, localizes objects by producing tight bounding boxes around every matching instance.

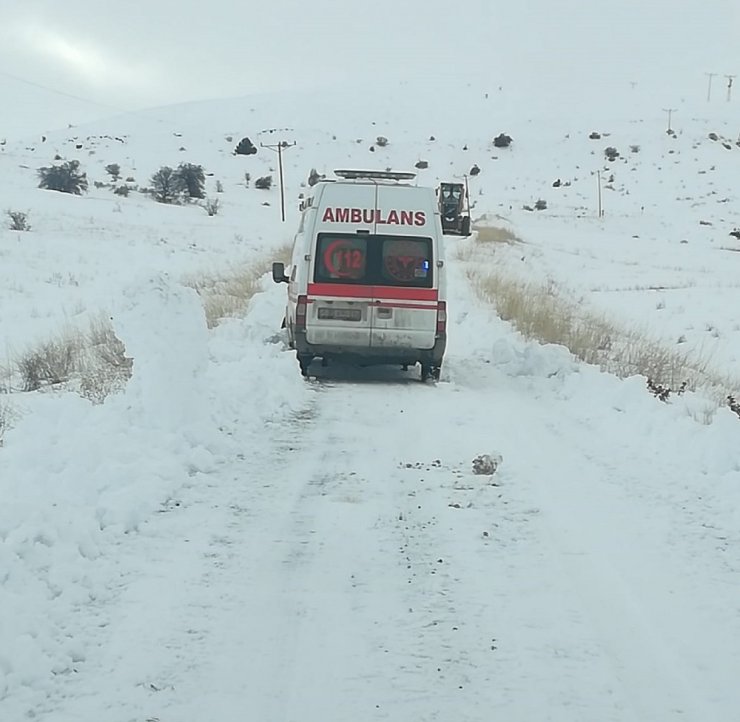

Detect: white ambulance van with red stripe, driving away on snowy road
[272,170,447,381]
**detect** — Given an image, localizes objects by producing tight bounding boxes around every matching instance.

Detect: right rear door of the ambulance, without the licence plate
[370,185,440,349]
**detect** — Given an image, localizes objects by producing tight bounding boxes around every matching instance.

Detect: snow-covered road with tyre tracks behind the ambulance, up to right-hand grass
[11,266,740,722]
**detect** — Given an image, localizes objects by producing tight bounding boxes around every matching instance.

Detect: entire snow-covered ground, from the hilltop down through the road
[0,83,740,722]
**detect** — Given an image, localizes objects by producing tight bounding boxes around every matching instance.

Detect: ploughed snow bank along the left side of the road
[0,276,308,716]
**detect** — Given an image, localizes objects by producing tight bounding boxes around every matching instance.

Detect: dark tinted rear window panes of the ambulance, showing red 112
[314,233,434,288]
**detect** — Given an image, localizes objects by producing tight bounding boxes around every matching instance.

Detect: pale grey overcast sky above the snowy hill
[0,0,740,129]
